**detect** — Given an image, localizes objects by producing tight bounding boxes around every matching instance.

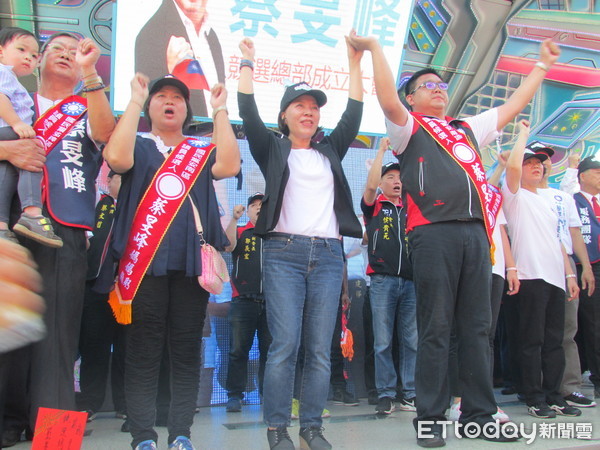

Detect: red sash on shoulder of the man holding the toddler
[33,95,87,155]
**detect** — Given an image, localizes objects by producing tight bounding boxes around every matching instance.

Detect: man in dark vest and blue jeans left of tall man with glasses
[361,138,417,415]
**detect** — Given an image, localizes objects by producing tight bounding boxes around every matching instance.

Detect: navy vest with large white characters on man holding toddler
[44,113,102,230]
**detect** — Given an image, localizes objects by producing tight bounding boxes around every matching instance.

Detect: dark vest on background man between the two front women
[231,222,262,297]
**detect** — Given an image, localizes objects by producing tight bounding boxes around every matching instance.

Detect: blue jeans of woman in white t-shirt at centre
[263,233,343,427]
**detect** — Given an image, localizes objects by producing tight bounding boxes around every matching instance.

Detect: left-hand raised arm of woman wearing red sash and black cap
[102,73,150,173]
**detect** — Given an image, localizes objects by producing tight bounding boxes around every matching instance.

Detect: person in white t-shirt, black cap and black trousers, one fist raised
[502,121,581,418]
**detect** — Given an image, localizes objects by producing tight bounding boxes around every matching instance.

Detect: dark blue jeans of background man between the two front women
[226,295,271,400]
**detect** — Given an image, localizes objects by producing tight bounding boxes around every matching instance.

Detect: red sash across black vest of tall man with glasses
[411,113,502,258]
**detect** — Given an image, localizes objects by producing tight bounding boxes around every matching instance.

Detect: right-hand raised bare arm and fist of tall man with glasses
[497,39,560,130]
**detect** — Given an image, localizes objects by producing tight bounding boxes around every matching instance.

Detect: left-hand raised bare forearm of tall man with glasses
[347,30,408,126]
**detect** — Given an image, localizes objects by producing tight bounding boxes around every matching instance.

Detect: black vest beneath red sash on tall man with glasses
[397,116,483,232]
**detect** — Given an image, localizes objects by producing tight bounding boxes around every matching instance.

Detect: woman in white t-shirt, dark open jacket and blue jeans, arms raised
[238,39,363,449]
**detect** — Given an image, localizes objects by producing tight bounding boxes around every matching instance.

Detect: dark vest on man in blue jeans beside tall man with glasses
[360,194,412,280]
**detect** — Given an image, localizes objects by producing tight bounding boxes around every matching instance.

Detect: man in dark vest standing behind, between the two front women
[225,192,271,412]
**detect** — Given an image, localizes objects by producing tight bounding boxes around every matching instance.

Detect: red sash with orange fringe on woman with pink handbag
[108,138,215,324]
